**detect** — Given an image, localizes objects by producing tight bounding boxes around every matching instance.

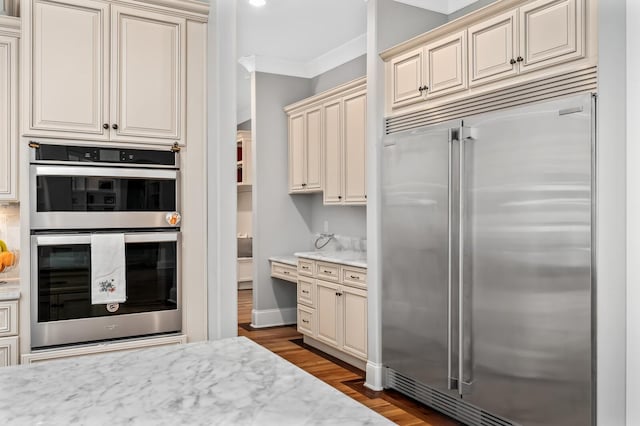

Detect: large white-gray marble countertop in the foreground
[0,337,392,425]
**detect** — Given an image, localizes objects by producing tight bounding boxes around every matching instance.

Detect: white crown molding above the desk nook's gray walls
[238,34,367,78]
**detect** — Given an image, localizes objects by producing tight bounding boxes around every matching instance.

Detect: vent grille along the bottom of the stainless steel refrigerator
[386,368,517,426]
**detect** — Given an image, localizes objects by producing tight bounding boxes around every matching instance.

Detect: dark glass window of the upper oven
[36,176,176,212]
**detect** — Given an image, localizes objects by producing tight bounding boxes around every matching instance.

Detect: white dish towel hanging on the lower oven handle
[91,234,127,305]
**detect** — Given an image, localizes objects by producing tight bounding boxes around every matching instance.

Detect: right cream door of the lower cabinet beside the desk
[341,286,367,360]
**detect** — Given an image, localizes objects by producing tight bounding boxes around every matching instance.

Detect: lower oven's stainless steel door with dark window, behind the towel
[31,231,182,349]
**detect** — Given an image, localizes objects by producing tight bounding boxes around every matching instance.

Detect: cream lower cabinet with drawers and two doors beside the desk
[298,259,367,361]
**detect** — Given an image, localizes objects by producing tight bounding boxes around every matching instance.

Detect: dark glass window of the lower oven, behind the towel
[37,241,178,322]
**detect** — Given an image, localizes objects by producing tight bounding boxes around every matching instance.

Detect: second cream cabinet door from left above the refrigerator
[425,30,467,98]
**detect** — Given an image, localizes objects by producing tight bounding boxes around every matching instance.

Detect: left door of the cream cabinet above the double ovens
[25,0,109,139]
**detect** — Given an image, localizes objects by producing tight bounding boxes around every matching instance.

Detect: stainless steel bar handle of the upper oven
[31,165,178,179]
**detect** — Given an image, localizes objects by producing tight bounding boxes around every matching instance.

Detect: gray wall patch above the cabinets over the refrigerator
[378,0,447,51]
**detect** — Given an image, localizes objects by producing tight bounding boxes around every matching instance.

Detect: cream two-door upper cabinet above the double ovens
[22,0,186,144]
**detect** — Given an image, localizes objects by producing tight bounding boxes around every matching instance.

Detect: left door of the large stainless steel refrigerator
[382,121,460,392]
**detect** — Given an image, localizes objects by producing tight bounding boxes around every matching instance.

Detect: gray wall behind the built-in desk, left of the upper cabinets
[253,72,311,326]
